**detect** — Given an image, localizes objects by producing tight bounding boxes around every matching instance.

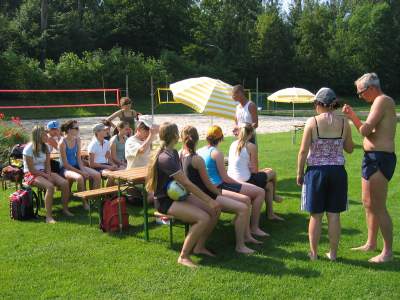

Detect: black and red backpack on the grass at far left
[10,188,39,220]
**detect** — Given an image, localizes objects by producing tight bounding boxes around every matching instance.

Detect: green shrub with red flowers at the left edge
[0,112,29,163]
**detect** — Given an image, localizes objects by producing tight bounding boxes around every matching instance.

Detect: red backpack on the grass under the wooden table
[100,197,129,232]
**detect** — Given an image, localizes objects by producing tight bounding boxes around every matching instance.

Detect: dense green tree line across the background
[0,0,400,95]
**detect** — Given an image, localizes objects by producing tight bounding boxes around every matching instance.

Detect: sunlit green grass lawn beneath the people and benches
[0,129,400,299]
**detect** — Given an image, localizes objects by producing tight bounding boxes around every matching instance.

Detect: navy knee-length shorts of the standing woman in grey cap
[301,166,348,214]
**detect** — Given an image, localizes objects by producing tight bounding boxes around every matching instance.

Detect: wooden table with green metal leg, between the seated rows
[104,167,149,241]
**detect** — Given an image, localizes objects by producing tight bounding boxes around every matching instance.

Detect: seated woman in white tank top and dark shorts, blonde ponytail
[228,124,283,221]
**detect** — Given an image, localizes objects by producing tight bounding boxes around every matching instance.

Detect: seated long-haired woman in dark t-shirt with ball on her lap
[146,123,220,267]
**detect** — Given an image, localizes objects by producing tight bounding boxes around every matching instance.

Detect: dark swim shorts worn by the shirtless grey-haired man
[361,151,397,181]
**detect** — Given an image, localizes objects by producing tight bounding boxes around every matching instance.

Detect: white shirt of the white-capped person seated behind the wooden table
[125,136,151,169]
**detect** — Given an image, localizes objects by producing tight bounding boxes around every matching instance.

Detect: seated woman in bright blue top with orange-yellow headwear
[197,125,268,236]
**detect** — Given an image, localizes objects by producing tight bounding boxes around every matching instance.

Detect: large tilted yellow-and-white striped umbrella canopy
[170,77,236,119]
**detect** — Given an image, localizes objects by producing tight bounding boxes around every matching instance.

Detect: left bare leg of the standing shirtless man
[351,178,379,251]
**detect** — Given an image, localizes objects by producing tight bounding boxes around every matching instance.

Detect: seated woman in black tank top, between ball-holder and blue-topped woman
[181,126,254,254]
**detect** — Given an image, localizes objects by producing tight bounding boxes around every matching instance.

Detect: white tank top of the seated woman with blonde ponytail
[228,141,251,182]
